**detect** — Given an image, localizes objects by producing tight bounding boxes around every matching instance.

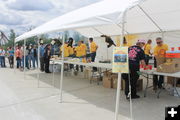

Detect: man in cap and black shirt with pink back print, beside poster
[122,40,146,99]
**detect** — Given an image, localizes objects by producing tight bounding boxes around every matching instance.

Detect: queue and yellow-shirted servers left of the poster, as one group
[0,37,98,73]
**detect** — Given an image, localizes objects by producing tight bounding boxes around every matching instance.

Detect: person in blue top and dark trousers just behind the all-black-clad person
[39,43,45,72]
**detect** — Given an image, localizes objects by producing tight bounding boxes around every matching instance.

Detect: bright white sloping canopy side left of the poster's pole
[16,0,142,42]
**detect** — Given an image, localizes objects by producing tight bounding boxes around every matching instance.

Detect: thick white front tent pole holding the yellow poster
[115,12,125,120]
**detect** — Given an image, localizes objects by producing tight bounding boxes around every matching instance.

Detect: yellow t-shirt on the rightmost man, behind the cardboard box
[154,44,168,57]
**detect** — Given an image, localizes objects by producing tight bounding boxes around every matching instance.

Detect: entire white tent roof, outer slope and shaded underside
[16,0,180,42]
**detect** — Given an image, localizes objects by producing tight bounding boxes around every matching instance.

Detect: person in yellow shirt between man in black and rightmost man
[144,39,152,65]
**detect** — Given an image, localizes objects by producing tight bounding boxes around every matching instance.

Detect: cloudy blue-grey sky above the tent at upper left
[0,0,101,34]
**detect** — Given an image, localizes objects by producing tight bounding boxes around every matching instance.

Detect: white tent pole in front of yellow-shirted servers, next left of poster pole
[60,35,65,103]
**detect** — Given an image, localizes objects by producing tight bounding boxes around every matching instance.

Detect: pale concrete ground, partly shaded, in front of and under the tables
[0,68,180,120]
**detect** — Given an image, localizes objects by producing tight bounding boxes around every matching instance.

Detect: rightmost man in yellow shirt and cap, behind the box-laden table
[153,37,168,90]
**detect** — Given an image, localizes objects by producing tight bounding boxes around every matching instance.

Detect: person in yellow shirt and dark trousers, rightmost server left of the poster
[89,38,98,72]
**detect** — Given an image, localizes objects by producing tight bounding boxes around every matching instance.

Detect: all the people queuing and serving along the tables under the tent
[0,37,168,99]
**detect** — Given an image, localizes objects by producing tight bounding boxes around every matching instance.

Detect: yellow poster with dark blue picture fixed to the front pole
[112,47,129,73]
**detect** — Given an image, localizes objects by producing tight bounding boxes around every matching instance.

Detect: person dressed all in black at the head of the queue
[44,44,51,73]
